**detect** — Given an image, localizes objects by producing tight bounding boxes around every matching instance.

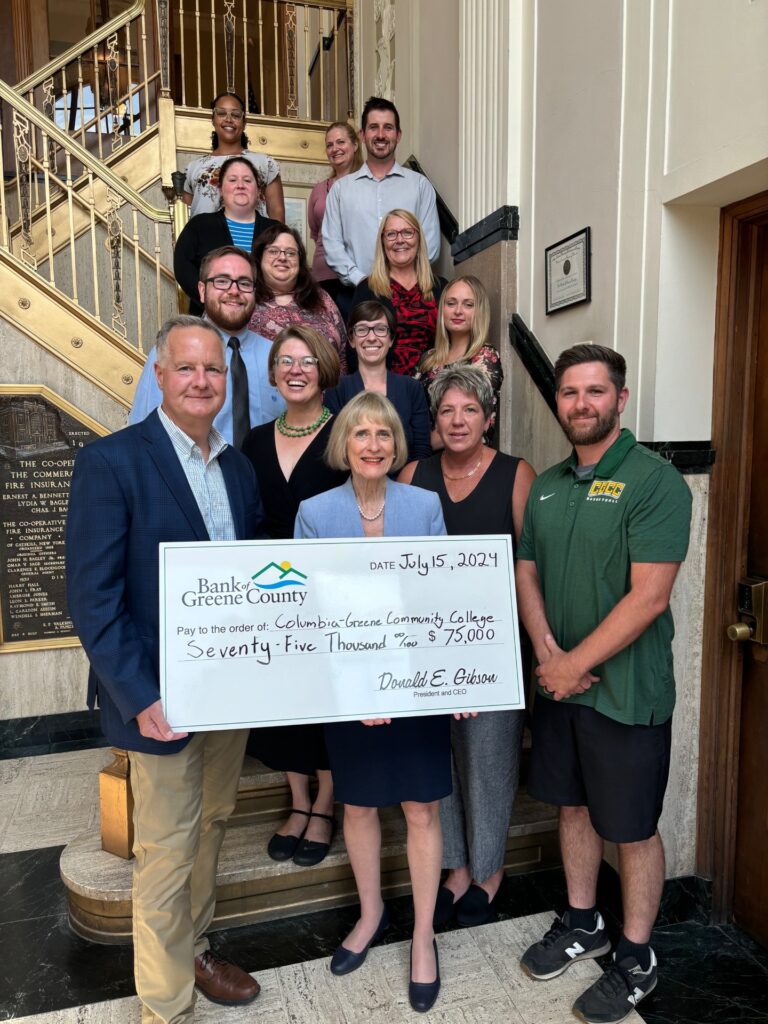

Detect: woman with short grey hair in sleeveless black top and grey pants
[399,365,536,926]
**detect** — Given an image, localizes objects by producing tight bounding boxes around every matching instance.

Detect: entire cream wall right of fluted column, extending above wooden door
[518,0,768,440]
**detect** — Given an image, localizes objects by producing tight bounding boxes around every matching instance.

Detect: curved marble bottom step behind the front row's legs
[60,790,559,943]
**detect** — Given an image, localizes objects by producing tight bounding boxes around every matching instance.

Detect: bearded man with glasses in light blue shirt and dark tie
[128,246,286,449]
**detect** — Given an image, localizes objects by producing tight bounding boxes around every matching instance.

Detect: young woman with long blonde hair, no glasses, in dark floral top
[414,274,504,452]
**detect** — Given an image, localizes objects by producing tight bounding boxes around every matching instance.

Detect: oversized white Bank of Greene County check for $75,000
[160,536,524,730]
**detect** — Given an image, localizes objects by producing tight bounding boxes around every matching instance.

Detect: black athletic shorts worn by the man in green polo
[528,694,672,843]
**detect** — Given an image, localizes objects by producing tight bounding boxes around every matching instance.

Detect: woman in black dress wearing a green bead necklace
[243,325,347,866]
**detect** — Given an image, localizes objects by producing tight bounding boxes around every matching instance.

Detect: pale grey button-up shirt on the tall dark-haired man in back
[323,164,440,285]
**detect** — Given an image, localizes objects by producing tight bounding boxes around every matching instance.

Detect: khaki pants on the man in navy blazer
[128,729,248,1024]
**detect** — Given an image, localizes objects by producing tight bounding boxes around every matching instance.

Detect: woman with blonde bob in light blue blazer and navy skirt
[294,391,452,1012]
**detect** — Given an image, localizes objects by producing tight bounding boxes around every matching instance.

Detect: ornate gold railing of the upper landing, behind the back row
[170,0,354,122]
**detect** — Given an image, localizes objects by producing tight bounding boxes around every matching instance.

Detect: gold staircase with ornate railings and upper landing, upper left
[0,0,353,409]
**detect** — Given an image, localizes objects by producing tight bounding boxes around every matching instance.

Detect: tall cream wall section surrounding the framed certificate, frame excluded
[518,0,622,380]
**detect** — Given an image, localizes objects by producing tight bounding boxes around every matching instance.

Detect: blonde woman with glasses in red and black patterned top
[352,209,445,376]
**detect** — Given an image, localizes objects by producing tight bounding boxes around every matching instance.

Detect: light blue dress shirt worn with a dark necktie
[128,325,286,444]
